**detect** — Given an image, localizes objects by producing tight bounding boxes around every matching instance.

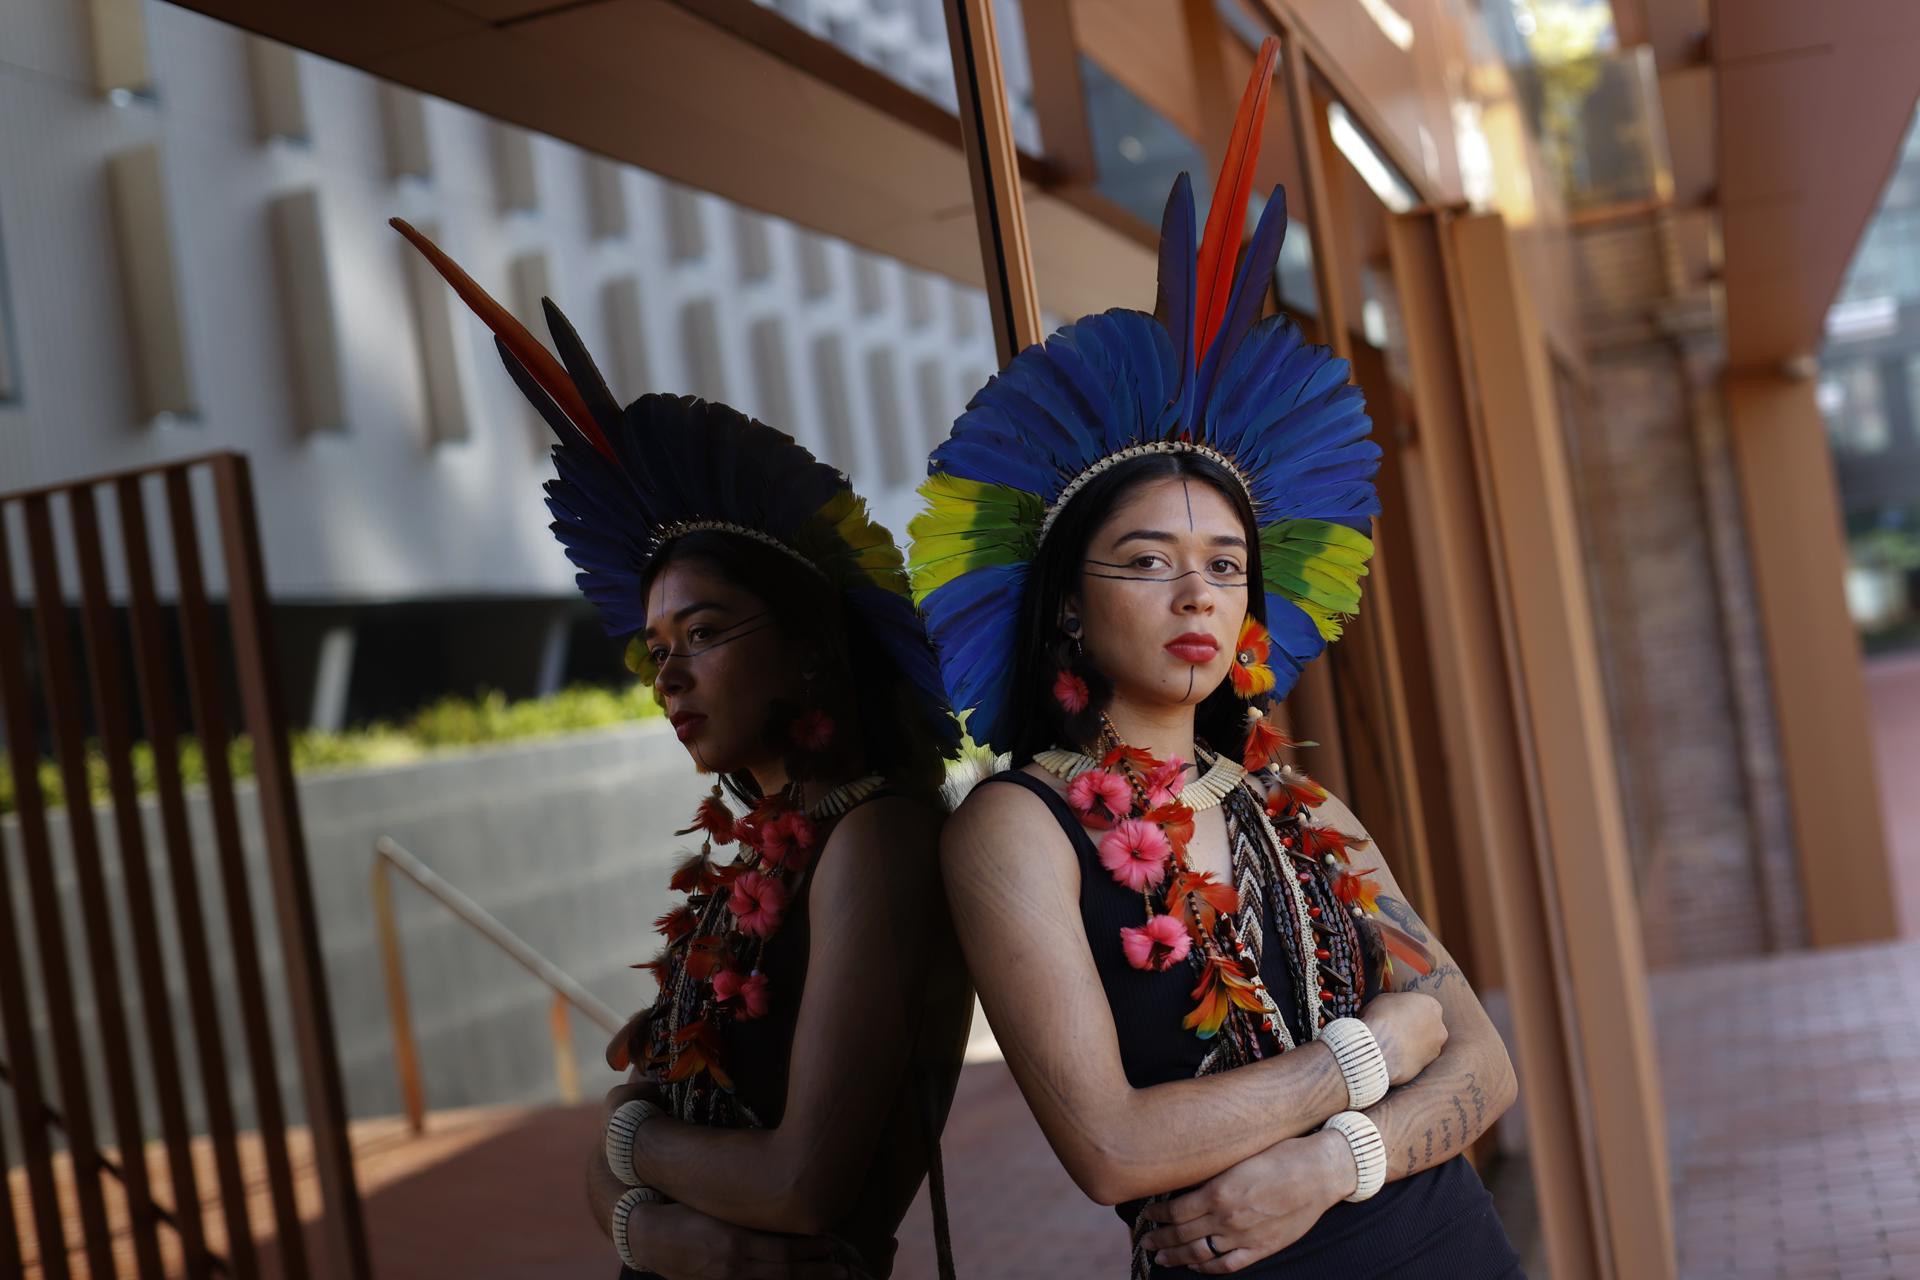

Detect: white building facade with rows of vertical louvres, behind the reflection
[0,0,1013,601]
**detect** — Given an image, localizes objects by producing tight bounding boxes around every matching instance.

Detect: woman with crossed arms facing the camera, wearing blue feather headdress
[912,40,1519,1280]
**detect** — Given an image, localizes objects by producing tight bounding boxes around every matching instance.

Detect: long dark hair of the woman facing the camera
[1010,453,1267,768]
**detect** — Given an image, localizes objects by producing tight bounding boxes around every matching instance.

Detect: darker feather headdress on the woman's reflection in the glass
[392,219,960,756]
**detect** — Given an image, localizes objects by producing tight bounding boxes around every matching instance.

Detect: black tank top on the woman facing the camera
[987,770,1521,1280]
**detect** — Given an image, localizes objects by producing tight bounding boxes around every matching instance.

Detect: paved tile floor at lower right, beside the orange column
[1655,942,1920,1280]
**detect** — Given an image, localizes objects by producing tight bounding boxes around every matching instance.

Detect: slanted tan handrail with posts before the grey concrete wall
[372,835,620,1132]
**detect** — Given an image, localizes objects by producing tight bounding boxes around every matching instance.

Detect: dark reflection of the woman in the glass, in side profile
[396,223,972,1280]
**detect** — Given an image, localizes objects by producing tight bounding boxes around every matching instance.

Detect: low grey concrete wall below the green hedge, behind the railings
[0,722,703,1151]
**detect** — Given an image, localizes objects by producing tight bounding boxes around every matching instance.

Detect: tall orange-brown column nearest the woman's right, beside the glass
[1446,215,1674,1280]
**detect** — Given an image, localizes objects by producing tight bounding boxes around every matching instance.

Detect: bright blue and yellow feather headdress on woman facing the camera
[908,38,1380,750]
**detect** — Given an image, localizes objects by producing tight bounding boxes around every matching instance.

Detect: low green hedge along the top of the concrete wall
[0,683,660,814]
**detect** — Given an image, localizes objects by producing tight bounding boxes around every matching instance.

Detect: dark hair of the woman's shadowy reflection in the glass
[641,530,947,804]
